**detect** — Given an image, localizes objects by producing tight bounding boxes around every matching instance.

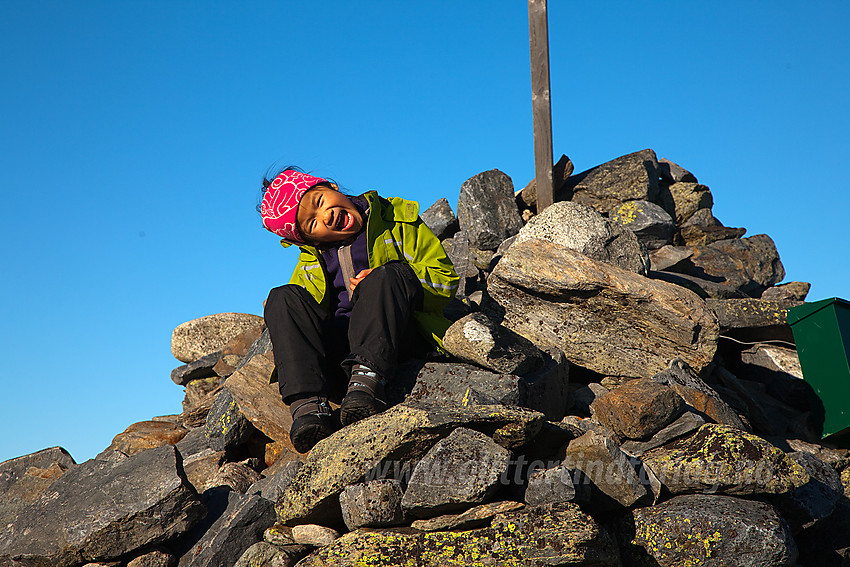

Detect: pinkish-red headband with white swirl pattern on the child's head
[261,170,327,244]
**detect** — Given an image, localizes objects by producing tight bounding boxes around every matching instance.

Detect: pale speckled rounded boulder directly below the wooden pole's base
[512,201,649,275]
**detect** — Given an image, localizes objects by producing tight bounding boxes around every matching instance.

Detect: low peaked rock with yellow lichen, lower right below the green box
[643,423,809,495]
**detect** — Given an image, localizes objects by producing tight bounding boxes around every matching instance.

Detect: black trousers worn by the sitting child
[264,262,423,404]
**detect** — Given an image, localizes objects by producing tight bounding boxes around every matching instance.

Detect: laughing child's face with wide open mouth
[296,187,363,244]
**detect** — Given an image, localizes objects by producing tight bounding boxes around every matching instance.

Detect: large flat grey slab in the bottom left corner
[0,446,205,567]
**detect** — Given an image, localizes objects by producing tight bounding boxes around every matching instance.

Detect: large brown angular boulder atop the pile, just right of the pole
[565,149,659,214]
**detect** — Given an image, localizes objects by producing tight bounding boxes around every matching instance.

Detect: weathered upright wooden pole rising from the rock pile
[528,0,554,213]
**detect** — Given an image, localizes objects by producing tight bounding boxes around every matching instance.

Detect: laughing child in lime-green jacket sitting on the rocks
[260,168,458,453]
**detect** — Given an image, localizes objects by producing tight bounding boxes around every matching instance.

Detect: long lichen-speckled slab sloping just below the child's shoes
[277,404,544,525]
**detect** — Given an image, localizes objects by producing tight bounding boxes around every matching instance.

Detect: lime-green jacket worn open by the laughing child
[281,191,459,349]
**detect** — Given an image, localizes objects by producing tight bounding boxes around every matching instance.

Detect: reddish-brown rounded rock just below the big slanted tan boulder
[592,378,685,439]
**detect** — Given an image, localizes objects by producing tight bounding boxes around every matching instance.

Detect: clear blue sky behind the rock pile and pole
[0,0,850,461]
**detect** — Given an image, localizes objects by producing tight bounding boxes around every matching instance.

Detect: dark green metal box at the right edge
[788,297,850,440]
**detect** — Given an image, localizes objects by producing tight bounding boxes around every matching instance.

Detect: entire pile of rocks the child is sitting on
[0,150,850,567]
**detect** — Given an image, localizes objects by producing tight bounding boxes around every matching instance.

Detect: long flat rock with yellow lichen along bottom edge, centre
[299,503,619,567]
